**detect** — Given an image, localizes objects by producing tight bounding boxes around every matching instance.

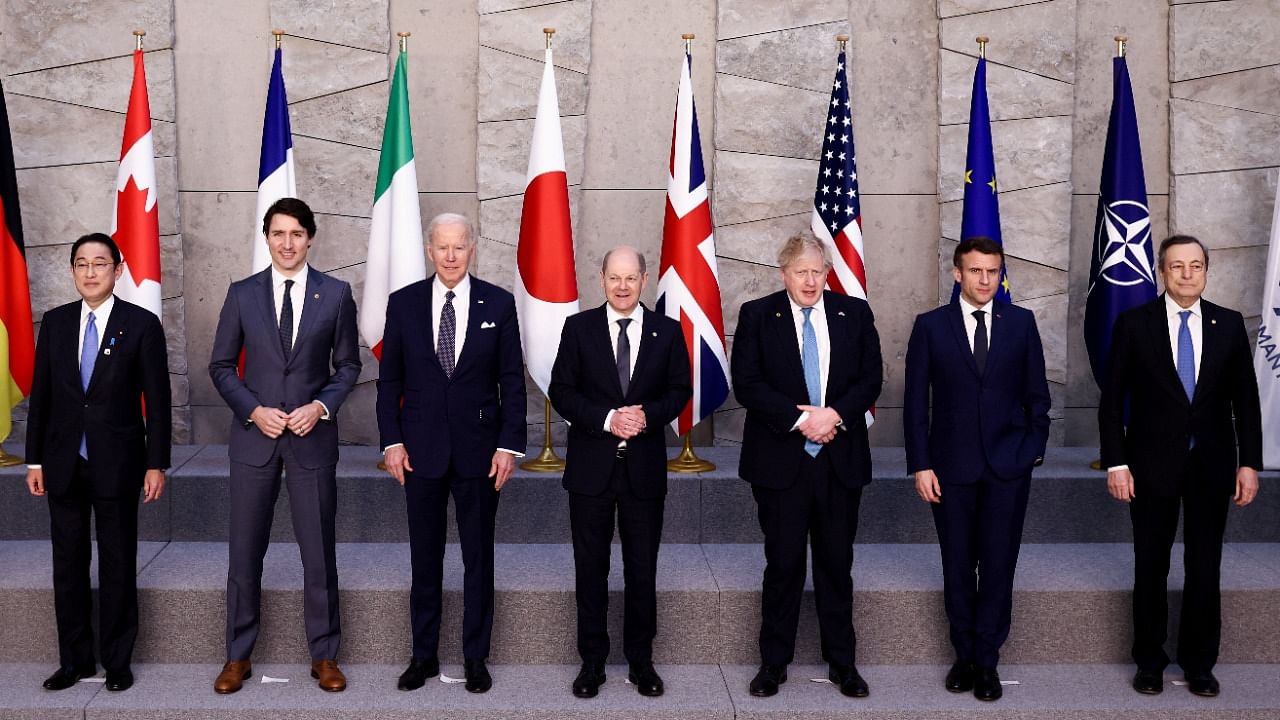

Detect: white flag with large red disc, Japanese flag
[515,47,577,395]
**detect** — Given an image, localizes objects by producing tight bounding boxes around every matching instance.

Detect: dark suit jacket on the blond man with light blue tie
[730,291,883,489]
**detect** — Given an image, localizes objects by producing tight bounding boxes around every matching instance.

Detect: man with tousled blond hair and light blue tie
[731,233,883,697]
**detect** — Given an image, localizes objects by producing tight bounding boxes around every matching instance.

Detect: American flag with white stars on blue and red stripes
[809,50,876,427]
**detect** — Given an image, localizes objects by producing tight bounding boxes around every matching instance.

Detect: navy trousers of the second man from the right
[932,469,1032,667]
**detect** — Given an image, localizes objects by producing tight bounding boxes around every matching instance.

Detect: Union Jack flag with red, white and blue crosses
[657,53,728,436]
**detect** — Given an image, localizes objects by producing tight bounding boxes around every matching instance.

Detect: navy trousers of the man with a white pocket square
[404,464,498,660]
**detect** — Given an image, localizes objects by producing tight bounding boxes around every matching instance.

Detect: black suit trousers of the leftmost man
[49,460,138,670]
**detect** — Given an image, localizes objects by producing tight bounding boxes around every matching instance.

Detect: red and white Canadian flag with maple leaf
[111,50,160,318]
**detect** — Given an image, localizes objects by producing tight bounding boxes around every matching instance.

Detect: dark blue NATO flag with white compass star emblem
[1084,56,1156,384]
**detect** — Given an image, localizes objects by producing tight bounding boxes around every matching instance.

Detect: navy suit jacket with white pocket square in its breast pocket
[378,275,526,478]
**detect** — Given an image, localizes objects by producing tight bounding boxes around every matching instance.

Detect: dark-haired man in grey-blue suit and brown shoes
[209,197,361,694]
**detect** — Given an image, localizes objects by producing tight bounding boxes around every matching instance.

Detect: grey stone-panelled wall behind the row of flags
[0,0,1280,445]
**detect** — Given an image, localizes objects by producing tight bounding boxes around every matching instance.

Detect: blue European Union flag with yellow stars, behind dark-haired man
[951,58,1012,302]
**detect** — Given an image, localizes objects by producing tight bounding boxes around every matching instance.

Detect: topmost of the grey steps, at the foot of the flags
[0,446,1280,543]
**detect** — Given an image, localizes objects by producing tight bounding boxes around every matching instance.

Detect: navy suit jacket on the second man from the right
[902,301,1050,484]
